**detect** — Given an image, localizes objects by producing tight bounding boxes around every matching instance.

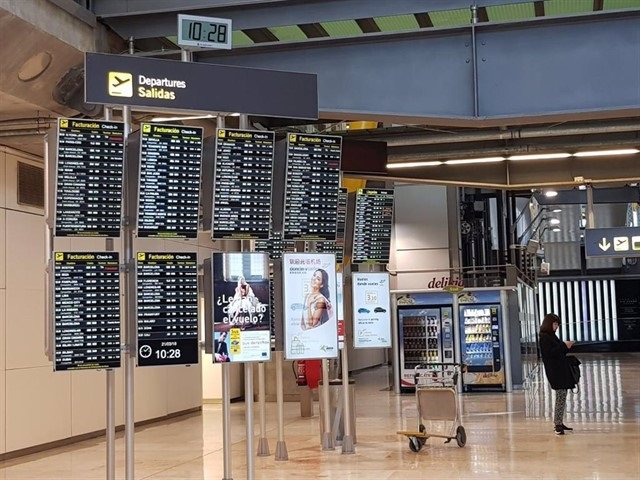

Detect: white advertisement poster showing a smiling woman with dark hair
[282,253,338,360]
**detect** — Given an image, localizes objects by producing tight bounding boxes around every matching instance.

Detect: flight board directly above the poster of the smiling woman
[284,133,342,241]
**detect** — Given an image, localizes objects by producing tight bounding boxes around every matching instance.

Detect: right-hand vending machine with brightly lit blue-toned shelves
[460,299,505,392]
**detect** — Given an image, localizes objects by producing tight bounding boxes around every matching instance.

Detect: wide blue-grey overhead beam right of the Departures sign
[197,11,640,127]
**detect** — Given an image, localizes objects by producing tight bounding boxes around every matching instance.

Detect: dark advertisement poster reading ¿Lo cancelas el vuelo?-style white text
[211,253,271,363]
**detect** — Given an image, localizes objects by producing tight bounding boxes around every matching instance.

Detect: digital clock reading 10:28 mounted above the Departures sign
[178,14,232,50]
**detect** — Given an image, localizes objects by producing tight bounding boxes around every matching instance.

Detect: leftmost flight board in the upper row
[55,118,124,237]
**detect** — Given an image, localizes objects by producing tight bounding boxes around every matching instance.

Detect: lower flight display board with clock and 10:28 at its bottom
[136,252,198,367]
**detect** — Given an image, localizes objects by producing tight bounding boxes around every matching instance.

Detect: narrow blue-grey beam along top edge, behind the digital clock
[94,0,530,38]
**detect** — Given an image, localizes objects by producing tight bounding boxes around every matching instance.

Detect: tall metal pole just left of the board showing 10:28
[122,33,136,480]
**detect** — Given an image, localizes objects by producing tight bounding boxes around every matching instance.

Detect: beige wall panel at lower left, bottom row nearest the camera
[6,367,71,452]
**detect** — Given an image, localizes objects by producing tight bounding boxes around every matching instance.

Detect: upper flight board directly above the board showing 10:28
[138,123,202,238]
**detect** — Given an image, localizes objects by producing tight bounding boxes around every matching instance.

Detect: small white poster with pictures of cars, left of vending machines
[352,272,391,348]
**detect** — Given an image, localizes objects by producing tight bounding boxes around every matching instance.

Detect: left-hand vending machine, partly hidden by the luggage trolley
[398,306,455,390]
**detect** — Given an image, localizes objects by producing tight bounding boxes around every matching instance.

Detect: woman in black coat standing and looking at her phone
[540,313,576,435]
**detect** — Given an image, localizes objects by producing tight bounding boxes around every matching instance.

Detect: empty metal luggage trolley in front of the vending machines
[398,363,467,452]
